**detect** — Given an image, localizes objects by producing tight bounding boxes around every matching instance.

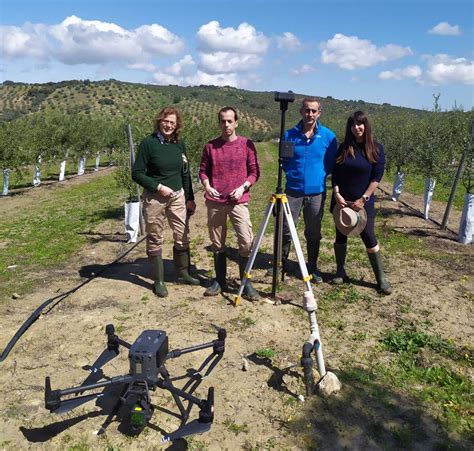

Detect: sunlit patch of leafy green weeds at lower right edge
[375,324,474,435]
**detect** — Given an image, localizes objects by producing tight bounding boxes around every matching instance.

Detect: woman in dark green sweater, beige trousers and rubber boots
[132,107,199,297]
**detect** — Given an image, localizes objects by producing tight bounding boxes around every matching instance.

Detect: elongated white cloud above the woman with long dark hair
[321,33,412,70]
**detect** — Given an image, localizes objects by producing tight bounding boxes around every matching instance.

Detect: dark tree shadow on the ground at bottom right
[287,367,472,450]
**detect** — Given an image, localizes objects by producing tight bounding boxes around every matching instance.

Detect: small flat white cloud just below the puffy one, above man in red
[199,52,262,74]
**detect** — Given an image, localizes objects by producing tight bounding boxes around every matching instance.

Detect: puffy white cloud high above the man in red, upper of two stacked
[197,20,269,54]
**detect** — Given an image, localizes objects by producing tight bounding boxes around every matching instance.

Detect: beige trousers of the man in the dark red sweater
[206,200,253,257]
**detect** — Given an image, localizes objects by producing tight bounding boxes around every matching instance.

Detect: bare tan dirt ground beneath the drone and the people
[0,171,474,450]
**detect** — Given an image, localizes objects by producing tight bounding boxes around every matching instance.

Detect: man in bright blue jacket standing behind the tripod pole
[282,97,337,283]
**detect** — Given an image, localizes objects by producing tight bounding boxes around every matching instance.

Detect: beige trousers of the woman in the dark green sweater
[143,190,189,256]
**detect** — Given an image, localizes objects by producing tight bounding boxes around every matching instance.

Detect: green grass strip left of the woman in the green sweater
[0,174,127,299]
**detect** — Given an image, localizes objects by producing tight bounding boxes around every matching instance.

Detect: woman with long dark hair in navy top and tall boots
[331,111,392,294]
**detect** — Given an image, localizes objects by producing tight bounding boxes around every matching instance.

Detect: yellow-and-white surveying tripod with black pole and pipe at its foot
[234,91,326,395]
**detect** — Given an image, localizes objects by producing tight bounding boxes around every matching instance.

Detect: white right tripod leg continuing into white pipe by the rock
[282,199,326,377]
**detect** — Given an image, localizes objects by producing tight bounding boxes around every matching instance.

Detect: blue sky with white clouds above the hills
[0,0,474,110]
